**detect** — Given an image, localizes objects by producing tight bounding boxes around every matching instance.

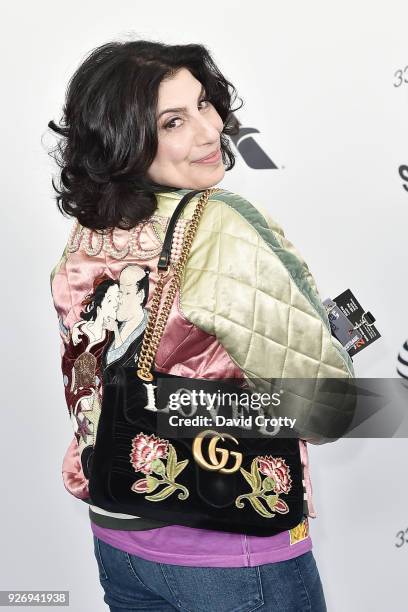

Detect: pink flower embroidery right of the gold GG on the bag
[235,455,292,518]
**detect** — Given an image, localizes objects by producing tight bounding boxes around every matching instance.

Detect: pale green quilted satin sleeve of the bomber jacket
[155,190,355,441]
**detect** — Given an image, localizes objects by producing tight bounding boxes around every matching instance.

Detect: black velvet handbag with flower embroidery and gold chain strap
[89,188,304,536]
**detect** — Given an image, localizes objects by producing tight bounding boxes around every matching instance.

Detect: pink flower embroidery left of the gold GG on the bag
[130,432,189,501]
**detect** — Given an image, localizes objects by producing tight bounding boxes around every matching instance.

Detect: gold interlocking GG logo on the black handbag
[192,429,242,474]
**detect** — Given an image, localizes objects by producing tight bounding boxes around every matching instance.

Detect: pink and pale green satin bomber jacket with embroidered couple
[50,189,354,518]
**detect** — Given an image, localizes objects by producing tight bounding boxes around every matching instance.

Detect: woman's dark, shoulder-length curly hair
[48,40,243,230]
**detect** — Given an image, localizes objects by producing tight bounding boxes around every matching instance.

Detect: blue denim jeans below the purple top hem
[93,535,327,612]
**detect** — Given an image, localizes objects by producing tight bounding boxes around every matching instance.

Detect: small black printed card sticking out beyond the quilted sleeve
[323,289,381,356]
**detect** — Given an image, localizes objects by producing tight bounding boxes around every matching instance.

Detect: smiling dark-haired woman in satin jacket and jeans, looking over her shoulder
[49,41,353,612]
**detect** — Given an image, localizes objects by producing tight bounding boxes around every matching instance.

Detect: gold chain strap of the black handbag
[137,187,222,381]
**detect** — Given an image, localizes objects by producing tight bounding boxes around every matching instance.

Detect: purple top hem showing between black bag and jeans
[91,517,312,567]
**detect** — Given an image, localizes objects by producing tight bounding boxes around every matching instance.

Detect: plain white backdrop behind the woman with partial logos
[0,0,408,612]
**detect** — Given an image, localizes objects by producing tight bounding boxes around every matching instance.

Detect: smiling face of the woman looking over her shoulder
[147,68,225,189]
